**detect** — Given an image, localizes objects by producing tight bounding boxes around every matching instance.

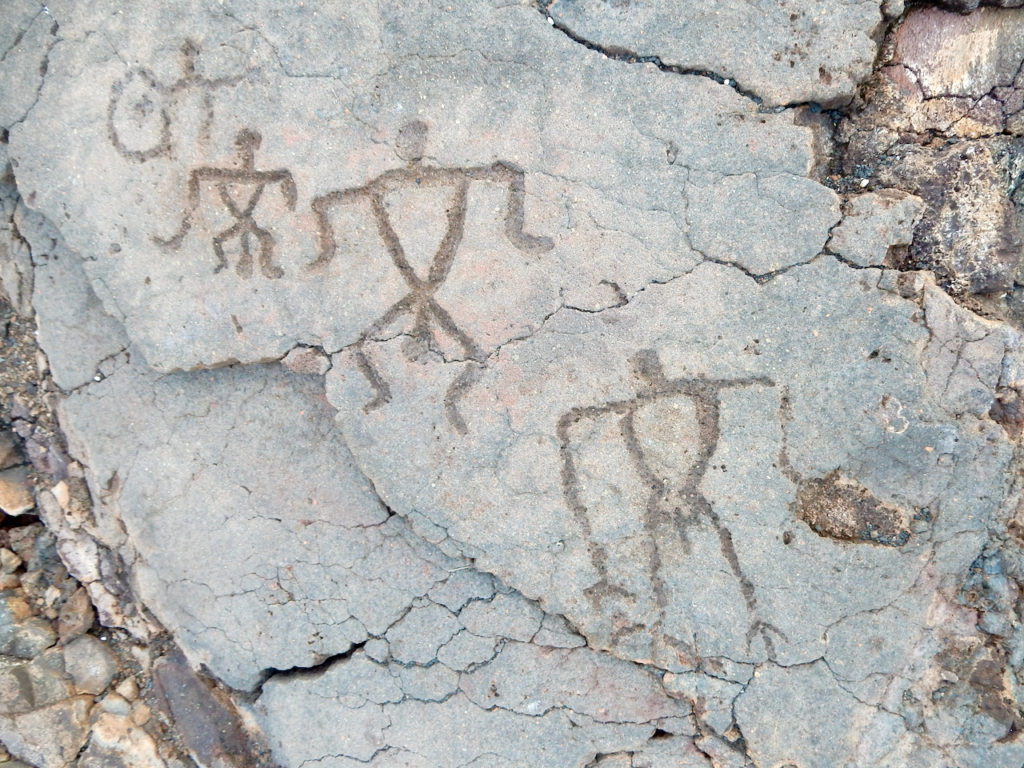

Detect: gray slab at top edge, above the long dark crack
[545,0,882,104]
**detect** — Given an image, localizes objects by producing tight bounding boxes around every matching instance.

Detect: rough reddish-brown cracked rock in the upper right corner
[839,8,1024,301]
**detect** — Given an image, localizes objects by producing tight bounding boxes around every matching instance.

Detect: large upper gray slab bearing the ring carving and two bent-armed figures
[10,1,814,371]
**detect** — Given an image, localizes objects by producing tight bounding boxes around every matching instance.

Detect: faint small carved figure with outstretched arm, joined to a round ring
[106,40,243,163]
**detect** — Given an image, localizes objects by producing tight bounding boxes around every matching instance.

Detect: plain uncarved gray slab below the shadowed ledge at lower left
[58,366,450,687]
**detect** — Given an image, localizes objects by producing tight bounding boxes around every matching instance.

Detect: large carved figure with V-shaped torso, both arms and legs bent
[309,121,554,434]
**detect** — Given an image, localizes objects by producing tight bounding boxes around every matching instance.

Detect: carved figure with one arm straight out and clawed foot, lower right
[557,349,784,655]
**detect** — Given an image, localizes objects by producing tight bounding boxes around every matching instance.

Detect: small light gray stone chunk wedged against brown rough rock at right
[828,189,925,266]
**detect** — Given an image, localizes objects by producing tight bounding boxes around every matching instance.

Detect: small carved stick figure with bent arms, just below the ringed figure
[153,129,298,280]
